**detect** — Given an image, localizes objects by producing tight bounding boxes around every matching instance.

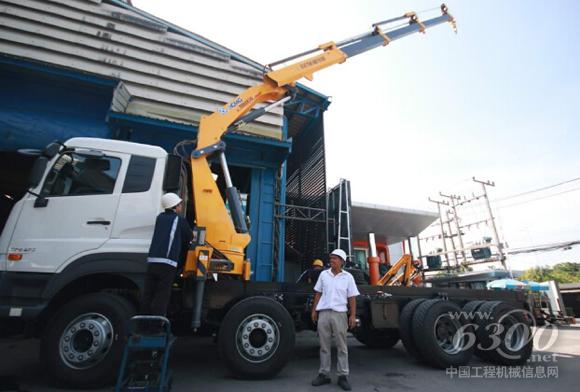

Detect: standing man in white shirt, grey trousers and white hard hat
[311,249,360,391]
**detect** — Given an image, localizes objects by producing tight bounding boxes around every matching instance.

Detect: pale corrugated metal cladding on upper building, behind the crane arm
[0,0,282,139]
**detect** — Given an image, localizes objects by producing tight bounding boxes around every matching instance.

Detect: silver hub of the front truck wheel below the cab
[59,313,113,369]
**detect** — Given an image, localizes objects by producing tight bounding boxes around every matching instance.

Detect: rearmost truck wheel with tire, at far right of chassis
[476,301,533,366]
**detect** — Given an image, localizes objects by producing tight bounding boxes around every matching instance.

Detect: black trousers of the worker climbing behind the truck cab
[141,263,177,316]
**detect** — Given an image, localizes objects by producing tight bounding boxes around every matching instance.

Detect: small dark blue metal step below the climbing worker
[115,316,175,392]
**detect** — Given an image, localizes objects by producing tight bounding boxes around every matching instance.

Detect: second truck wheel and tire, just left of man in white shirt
[218,297,295,379]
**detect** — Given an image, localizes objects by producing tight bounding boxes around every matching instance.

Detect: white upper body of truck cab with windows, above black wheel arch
[0,138,168,273]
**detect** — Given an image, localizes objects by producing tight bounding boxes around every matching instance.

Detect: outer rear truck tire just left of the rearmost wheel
[413,300,475,369]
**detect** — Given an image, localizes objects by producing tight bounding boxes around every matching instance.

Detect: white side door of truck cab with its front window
[7,151,128,273]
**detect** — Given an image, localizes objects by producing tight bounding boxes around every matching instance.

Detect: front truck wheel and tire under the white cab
[40,293,135,388]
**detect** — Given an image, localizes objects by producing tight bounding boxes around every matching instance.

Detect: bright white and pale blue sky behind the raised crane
[133,0,580,269]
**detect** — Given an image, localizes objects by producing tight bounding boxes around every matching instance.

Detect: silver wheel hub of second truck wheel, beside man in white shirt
[236,314,280,363]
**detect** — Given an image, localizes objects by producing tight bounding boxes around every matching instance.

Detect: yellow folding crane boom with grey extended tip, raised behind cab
[184,4,455,327]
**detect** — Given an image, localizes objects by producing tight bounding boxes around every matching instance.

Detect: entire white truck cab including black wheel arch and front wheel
[0,138,181,386]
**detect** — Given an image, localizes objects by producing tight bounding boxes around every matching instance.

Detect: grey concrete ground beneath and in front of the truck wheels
[0,327,580,392]
